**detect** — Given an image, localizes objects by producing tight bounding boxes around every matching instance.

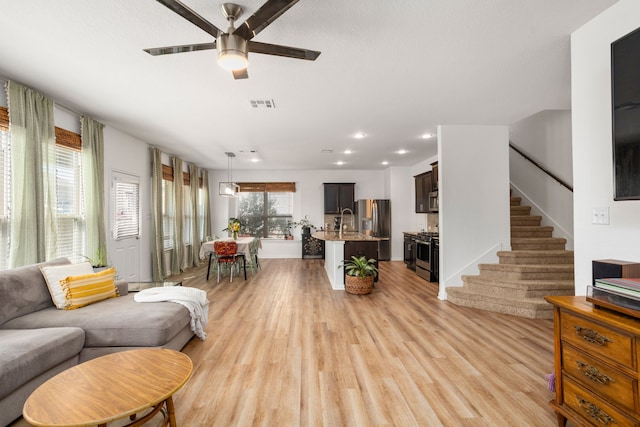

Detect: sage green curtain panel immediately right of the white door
[151,148,167,282]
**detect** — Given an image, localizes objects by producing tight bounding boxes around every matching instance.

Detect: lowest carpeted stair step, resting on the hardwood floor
[447,287,553,319]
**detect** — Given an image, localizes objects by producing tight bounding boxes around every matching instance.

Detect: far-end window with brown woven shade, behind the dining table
[238,183,295,238]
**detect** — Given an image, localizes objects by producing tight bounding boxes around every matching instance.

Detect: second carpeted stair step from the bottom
[462,275,575,298]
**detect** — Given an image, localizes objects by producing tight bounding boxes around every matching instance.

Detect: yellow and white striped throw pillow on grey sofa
[60,267,118,310]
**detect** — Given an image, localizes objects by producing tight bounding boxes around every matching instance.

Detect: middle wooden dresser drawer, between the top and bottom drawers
[562,344,638,411]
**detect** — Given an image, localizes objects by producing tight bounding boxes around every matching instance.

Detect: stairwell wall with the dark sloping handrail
[509,110,574,249]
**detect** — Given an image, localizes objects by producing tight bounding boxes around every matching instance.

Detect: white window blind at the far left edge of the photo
[0,130,11,270]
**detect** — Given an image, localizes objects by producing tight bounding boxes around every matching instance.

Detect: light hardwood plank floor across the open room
[168,259,556,426]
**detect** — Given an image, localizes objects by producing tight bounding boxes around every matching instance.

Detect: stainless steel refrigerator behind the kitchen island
[356,199,391,261]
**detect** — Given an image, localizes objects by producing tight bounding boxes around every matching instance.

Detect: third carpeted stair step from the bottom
[478,264,573,281]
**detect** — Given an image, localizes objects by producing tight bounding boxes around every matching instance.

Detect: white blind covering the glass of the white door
[112,173,140,240]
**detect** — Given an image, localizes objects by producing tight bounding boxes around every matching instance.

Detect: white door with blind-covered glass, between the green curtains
[109,170,141,282]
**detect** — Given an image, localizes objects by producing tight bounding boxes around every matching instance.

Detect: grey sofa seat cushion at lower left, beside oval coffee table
[0,328,84,399]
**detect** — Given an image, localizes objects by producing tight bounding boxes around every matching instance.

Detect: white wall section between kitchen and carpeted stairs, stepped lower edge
[438,126,510,299]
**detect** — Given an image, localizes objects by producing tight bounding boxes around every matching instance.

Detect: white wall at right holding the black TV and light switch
[571,0,640,295]
